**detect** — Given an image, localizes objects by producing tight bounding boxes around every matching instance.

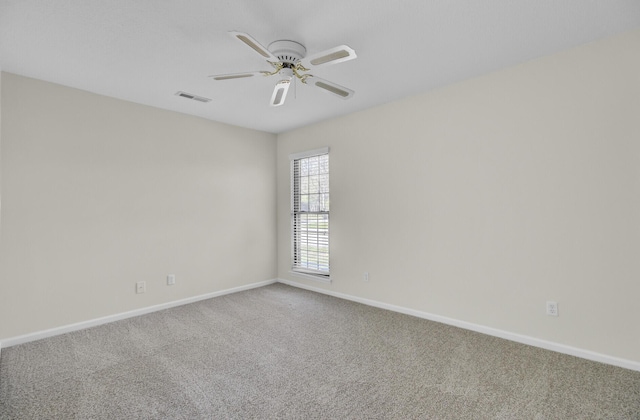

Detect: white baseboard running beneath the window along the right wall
[277,279,640,372]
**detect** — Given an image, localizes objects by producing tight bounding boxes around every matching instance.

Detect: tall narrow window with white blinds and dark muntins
[290,148,329,280]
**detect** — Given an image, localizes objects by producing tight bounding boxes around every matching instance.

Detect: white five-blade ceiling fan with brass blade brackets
[209,31,357,106]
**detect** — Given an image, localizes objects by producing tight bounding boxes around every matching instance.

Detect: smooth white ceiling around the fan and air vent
[0,0,640,133]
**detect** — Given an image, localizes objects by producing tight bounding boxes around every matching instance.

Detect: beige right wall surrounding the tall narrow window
[278,30,640,361]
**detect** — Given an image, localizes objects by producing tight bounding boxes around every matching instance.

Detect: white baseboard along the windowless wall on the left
[0,279,277,349]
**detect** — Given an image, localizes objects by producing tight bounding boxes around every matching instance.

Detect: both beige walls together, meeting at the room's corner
[0,31,640,361]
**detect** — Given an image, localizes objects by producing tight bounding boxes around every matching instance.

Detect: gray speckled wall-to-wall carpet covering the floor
[0,284,640,419]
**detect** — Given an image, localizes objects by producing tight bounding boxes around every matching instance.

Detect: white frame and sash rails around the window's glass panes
[289,147,331,283]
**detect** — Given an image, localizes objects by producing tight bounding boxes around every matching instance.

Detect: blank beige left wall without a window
[0,73,276,340]
